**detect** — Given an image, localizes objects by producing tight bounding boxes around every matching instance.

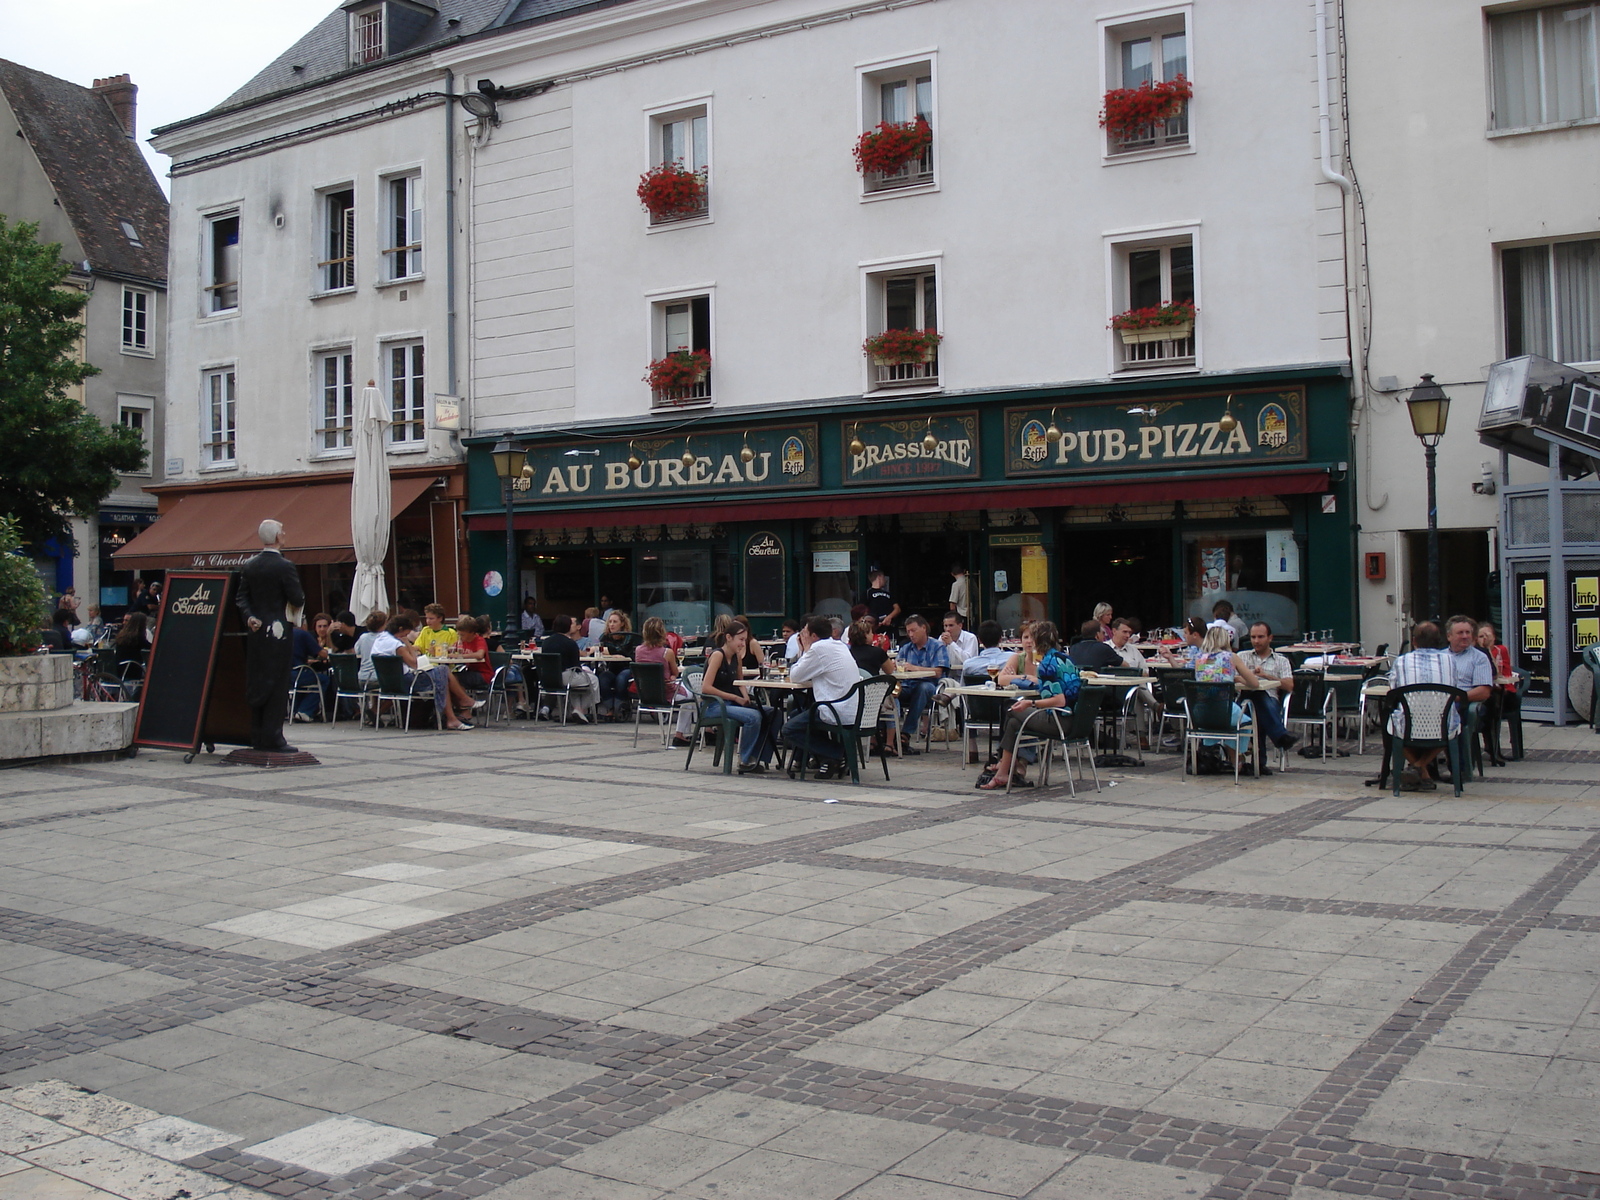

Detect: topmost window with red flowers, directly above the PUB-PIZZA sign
[1102,11,1189,155]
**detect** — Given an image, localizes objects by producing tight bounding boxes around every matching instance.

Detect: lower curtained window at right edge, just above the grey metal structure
[1501,238,1600,363]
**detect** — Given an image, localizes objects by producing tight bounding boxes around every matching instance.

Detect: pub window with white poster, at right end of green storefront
[1184,530,1301,638]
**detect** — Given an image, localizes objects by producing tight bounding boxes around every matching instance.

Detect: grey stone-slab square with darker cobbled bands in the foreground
[0,722,1600,1200]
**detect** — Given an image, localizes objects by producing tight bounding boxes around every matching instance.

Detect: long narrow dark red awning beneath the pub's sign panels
[467,467,1328,531]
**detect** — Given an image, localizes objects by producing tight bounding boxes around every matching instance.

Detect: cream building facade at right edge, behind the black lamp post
[1344,0,1600,659]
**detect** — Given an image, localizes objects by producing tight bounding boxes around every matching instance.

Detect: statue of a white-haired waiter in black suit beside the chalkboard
[237,520,306,752]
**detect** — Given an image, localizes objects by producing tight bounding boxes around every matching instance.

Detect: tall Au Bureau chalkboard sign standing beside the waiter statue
[133,571,250,762]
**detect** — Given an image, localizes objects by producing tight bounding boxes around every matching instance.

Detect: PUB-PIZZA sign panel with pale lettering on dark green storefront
[1005,387,1306,475]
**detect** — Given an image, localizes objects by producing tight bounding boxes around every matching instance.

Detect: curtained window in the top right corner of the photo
[1490,3,1600,130]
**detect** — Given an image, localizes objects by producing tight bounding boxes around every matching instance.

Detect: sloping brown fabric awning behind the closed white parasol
[112,475,434,571]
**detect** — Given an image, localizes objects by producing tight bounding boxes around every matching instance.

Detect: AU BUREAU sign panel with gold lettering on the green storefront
[514,424,821,502]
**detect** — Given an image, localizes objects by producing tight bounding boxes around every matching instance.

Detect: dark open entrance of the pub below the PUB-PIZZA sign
[1058,526,1174,640]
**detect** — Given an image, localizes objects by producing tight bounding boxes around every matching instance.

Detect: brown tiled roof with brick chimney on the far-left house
[0,59,166,283]
